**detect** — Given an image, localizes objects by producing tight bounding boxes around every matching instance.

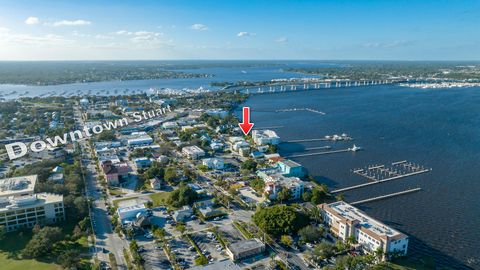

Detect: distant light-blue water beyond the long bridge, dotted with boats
[0,61,334,99]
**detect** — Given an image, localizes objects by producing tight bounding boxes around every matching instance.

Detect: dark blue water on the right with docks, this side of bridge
[242,86,480,269]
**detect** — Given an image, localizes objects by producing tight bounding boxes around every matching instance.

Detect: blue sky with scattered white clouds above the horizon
[0,0,480,60]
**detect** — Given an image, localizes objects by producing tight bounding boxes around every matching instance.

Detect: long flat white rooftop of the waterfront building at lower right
[328,201,402,237]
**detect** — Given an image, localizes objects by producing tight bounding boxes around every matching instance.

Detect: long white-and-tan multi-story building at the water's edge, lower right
[319,201,408,256]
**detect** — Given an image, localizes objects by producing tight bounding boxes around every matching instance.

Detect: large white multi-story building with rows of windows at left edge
[0,175,65,231]
